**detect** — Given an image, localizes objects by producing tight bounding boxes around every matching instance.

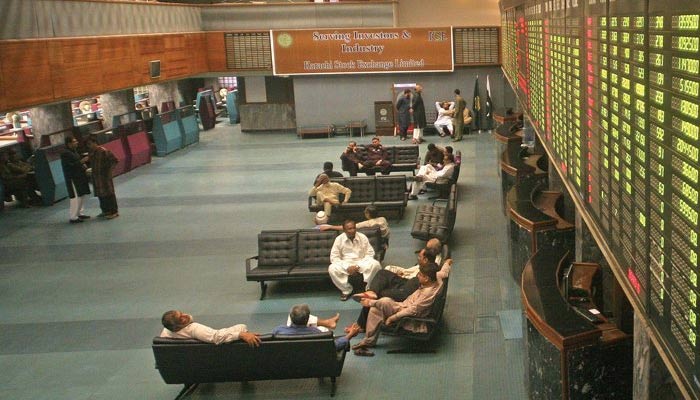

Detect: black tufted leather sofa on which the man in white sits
[245,227,384,300]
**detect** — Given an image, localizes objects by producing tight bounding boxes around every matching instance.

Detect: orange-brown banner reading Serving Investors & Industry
[270,27,454,75]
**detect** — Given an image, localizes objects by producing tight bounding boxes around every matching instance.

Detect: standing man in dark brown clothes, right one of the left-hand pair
[85,137,119,219]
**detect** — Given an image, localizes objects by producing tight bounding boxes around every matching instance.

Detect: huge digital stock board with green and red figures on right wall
[501,0,700,397]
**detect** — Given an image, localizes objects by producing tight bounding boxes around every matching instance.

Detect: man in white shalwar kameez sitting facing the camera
[328,220,382,301]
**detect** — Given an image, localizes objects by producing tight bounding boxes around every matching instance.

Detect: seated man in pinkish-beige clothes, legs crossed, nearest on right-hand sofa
[352,262,441,356]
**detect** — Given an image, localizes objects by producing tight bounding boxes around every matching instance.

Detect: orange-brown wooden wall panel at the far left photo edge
[0,41,54,109]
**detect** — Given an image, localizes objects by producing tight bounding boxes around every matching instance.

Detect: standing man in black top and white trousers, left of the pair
[61,136,90,224]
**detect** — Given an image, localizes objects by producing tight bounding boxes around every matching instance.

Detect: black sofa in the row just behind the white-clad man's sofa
[309,175,408,220]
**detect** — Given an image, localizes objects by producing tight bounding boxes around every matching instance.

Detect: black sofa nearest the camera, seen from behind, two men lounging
[152,332,348,399]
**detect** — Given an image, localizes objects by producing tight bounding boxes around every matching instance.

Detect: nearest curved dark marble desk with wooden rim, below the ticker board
[521,248,633,400]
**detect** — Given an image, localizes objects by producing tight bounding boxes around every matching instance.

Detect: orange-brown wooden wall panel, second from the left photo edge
[49,38,103,99]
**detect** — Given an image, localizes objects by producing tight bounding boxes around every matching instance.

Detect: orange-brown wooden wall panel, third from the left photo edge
[100,36,137,92]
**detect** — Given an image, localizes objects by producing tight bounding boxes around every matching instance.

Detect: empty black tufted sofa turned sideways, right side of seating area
[411,184,457,243]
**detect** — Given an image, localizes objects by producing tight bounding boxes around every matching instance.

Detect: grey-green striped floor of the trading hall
[0,122,525,400]
